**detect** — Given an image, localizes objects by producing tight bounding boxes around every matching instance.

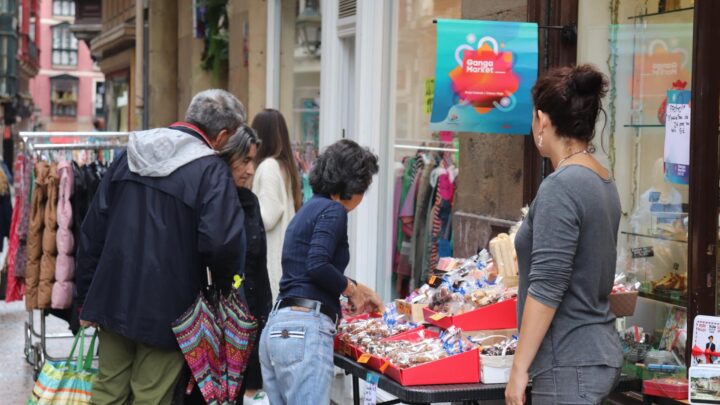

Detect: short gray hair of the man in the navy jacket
[185,89,247,139]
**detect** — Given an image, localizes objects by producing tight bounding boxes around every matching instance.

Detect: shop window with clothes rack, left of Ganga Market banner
[383,0,462,297]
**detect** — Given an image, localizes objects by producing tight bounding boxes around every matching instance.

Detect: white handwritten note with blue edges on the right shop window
[665,90,690,184]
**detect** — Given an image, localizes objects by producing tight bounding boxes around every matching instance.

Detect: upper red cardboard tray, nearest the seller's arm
[423,298,517,331]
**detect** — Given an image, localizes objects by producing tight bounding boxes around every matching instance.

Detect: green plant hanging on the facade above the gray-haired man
[197,0,229,81]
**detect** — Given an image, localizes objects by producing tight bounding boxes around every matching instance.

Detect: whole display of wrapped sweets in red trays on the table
[335,246,518,385]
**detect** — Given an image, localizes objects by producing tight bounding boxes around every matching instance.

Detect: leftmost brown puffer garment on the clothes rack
[25,162,50,309]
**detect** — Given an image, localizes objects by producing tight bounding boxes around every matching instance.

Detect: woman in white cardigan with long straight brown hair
[252,109,302,299]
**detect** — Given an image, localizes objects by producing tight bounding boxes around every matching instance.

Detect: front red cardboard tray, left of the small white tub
[378,329,480,386]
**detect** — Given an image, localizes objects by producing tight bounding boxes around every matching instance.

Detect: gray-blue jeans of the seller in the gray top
[532,366,620,405]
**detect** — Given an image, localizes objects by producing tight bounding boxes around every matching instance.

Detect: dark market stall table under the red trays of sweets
[335,353,642,405]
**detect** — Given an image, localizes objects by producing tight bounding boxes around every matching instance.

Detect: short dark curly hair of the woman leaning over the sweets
[310,139,379,200]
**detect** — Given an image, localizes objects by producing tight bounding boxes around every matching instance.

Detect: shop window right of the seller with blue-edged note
[577,0,694,363]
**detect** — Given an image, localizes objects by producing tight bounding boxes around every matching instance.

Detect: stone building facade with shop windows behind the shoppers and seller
[76,0,720,400]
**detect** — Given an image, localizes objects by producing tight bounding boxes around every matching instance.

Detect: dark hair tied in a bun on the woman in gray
[532,65,608,142]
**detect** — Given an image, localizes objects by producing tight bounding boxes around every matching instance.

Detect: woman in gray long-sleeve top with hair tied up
[505,65,623,405]
